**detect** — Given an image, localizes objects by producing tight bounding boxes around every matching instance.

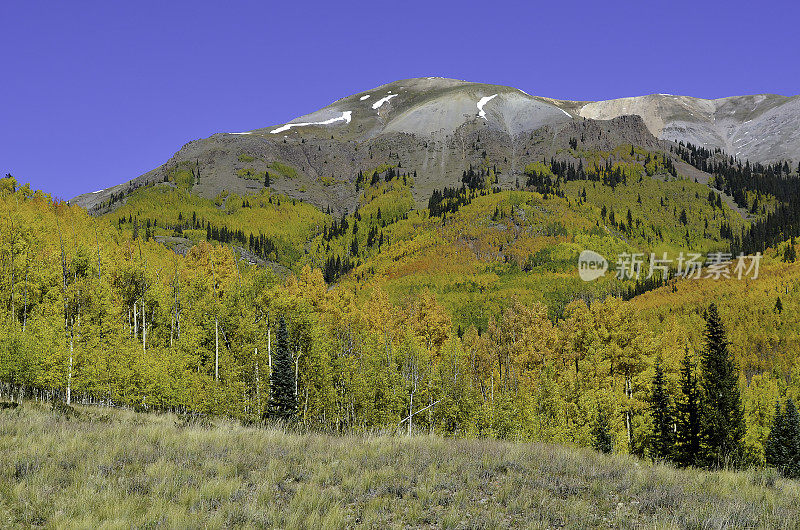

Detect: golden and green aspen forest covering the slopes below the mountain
[0,146,800,465]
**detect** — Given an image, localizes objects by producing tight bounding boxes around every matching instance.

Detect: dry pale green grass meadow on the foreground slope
[0,403,800,528]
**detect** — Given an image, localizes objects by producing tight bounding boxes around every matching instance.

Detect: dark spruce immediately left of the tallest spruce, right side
[675,348,700,467]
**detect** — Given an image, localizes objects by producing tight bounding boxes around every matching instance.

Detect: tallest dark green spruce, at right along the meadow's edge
[700,303,745,467]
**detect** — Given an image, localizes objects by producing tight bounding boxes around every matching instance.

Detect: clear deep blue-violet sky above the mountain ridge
[0,0,800,198]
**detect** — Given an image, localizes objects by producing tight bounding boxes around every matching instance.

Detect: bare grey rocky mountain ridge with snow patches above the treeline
[71,78,780,213]
